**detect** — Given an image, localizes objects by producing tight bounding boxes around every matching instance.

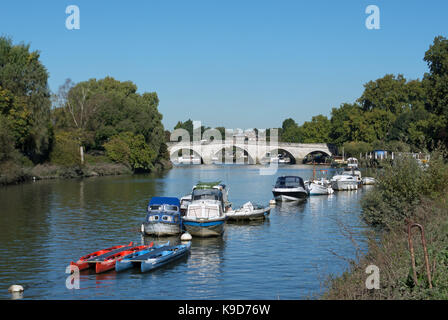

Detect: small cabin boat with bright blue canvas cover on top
[142,197,182,236]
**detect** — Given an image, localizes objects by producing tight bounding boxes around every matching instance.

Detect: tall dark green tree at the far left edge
[0,37,53,162]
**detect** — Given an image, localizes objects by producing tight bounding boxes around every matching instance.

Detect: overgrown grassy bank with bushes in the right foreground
[322,155,448,300]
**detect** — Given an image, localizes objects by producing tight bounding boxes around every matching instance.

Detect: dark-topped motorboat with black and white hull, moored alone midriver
[272,176,309,201]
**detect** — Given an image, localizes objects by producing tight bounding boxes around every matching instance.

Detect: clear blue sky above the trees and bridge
[0,0,448,129]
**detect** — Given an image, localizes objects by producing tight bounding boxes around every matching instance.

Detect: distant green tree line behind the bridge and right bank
[174,36,448,156]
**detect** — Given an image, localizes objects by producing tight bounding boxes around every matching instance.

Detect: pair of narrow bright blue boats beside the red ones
[115,242,191,272]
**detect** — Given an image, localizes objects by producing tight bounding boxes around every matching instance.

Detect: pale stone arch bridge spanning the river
[167,141,336,164]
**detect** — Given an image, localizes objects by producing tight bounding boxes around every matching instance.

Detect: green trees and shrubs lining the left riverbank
[0,37,171,184]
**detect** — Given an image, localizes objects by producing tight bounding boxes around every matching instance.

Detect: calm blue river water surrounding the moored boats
[0,165,368,299]
